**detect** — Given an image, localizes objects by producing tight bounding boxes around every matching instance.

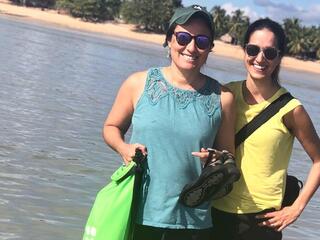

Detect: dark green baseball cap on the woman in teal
[163,5,214,47]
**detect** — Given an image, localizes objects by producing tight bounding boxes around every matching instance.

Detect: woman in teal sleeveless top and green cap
[104,5,234,240]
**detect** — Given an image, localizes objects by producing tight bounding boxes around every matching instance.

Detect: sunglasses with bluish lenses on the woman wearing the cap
[174,32,211,50]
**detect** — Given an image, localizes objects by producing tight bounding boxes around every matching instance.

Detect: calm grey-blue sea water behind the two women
[0,16,320,240]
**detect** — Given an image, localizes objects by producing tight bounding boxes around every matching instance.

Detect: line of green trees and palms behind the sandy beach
[10,0,320,60]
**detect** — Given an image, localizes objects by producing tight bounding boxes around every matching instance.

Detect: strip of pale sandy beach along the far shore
[0,0,320,73]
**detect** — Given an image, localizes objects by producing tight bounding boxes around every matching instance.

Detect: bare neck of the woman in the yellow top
[243,75,280,104]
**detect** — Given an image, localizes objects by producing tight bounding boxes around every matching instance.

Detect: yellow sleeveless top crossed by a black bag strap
[213,81,301,214]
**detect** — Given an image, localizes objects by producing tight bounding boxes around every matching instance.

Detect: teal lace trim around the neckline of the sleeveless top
[145,68,220,116]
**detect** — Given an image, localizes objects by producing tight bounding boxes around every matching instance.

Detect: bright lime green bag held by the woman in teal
[83,153,142,240]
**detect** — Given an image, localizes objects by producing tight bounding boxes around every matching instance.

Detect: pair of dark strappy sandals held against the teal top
[179,148,240,207]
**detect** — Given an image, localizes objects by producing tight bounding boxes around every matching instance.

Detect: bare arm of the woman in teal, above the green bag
[103,72,146,164]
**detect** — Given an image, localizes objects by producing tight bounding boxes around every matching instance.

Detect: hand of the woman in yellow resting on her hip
[256,205,301,232]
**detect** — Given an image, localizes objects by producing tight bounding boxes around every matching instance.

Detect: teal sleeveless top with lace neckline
[130,68,221,229]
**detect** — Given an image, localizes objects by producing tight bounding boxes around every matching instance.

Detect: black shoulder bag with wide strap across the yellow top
[235,93,303,207]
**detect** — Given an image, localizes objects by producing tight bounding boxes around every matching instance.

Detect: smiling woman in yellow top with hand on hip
[194,19,320,240]
